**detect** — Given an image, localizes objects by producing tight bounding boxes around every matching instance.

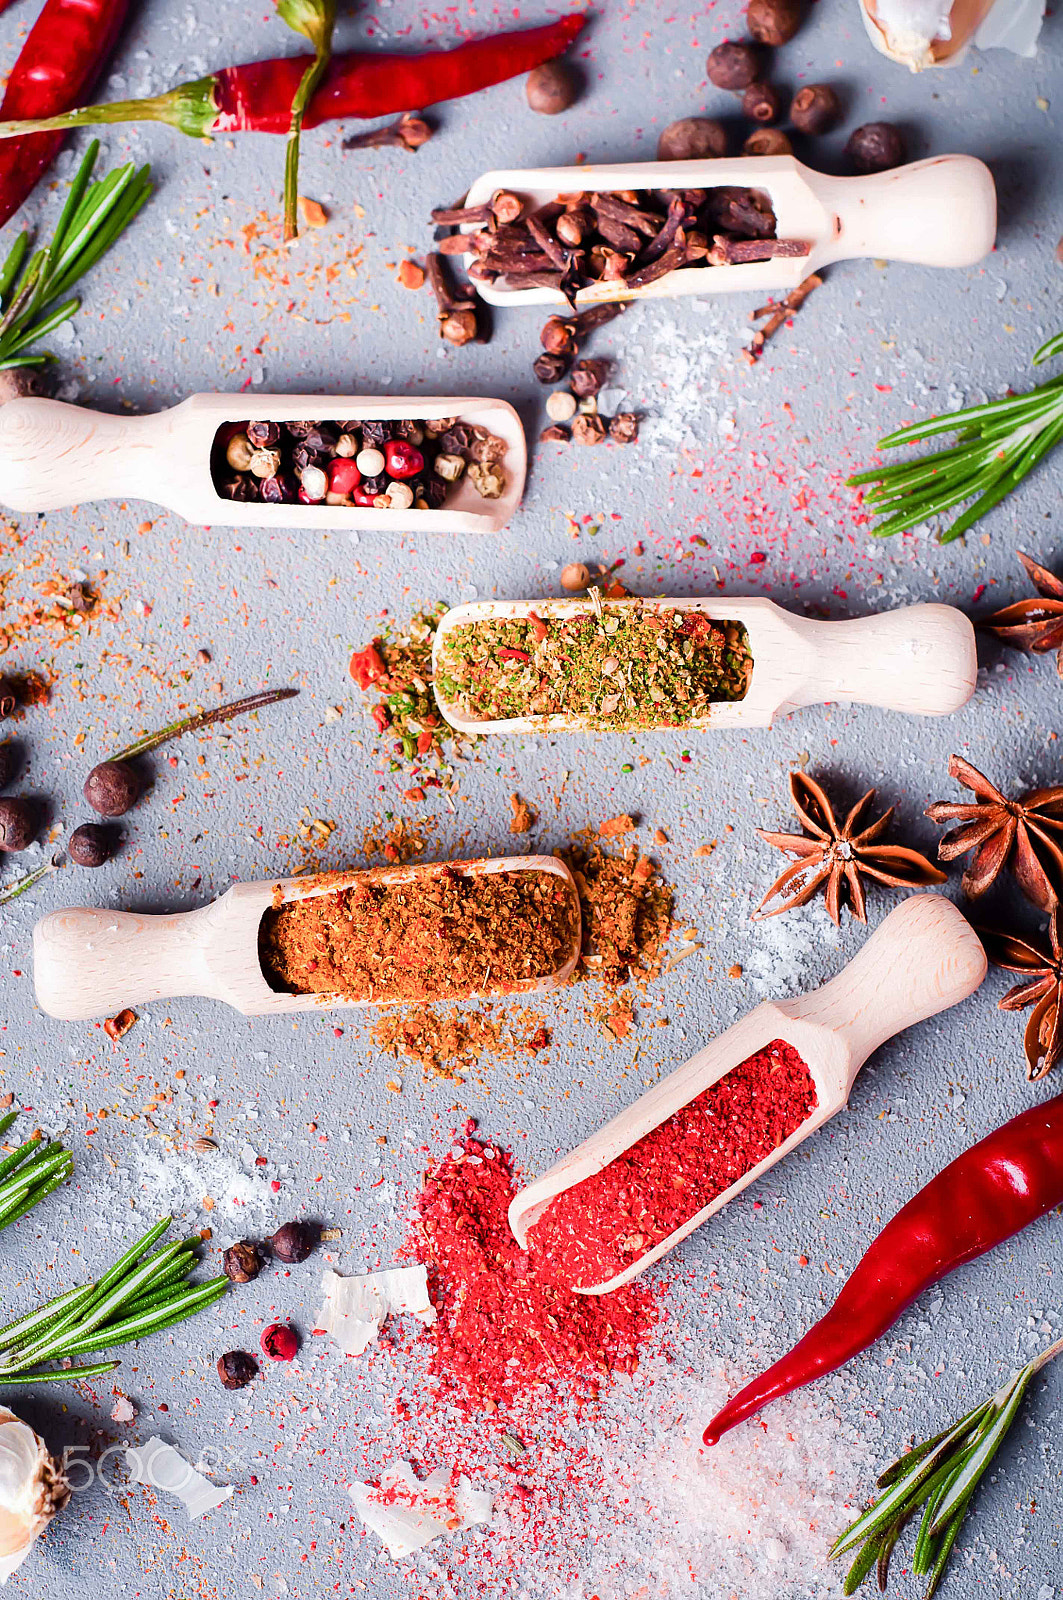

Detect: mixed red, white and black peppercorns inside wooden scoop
[211,416,506,510]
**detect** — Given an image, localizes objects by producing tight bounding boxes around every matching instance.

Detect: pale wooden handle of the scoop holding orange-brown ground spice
[34,906,216,1022]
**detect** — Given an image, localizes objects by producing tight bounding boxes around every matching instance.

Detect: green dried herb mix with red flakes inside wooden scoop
[437,592,752,728]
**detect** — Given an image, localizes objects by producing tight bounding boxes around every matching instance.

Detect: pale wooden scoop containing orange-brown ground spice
[34,856,580,1021]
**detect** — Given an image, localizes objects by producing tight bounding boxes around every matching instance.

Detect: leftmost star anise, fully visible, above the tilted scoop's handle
[754,773,945,923]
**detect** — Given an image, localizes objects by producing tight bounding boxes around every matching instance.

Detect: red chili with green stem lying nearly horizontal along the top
[0,14,586,139]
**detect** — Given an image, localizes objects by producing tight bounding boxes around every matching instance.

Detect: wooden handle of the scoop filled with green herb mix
[789,605,978,717]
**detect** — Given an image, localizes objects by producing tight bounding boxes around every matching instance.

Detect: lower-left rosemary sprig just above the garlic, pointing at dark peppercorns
[0,1216,229,1386]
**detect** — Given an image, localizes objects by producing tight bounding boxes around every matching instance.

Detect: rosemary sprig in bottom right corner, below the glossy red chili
[831,1339,1063,1600]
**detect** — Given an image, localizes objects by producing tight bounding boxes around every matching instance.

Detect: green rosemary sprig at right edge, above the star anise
[848,333,1063,544]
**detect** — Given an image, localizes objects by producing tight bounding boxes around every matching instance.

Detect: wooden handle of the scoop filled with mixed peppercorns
[0,400,166,512]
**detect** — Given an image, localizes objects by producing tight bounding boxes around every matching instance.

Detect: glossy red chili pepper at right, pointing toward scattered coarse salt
[704,1094,1063,1445]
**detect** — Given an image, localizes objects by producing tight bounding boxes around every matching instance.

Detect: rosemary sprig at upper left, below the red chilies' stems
[0,139,152,371]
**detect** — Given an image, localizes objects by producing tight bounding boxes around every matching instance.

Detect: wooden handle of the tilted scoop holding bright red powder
[780,894,986,1096]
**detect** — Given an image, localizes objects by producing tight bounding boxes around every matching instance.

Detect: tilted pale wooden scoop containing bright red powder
[509,894,986,1294]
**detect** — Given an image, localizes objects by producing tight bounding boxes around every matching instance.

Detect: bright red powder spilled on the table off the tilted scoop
[415,1120,658,1410]
